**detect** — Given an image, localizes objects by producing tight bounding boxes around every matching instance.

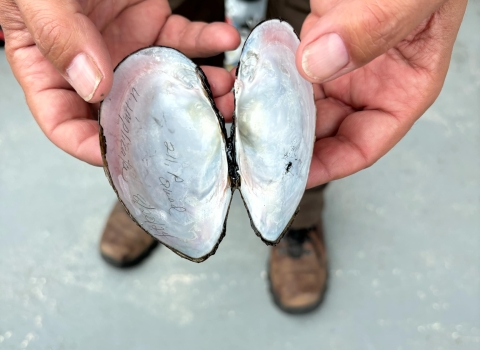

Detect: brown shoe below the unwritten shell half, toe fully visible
[269,227,327,314]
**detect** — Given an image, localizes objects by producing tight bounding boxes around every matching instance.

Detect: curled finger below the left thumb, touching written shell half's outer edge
[7,37,102,165]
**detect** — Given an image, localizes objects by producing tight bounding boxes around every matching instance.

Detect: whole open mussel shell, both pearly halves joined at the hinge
[100,20,315,262]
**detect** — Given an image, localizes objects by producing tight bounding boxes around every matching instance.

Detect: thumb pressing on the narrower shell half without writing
[296,0,445,83]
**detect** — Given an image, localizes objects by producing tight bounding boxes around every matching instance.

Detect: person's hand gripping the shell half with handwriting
[0,0,240,165]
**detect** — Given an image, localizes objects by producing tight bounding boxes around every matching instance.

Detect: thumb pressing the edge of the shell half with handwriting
[17,0,113,102]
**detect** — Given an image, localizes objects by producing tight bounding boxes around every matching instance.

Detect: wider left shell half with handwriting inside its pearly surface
[100,47,232,261]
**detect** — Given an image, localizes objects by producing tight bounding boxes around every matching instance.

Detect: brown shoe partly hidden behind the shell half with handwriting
[100,202,158,267]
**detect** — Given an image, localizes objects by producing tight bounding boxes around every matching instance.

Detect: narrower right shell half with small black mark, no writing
[235,20,316,244]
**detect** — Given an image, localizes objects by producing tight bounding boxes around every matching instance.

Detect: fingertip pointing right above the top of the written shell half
[156,15,240,57]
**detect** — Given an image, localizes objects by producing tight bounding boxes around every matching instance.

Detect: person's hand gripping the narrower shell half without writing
[297,0,467,188]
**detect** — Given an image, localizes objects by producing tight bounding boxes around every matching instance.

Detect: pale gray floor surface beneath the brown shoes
[0,1,480,350]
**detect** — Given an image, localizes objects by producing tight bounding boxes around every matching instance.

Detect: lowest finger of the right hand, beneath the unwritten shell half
[307,111,410,188]
